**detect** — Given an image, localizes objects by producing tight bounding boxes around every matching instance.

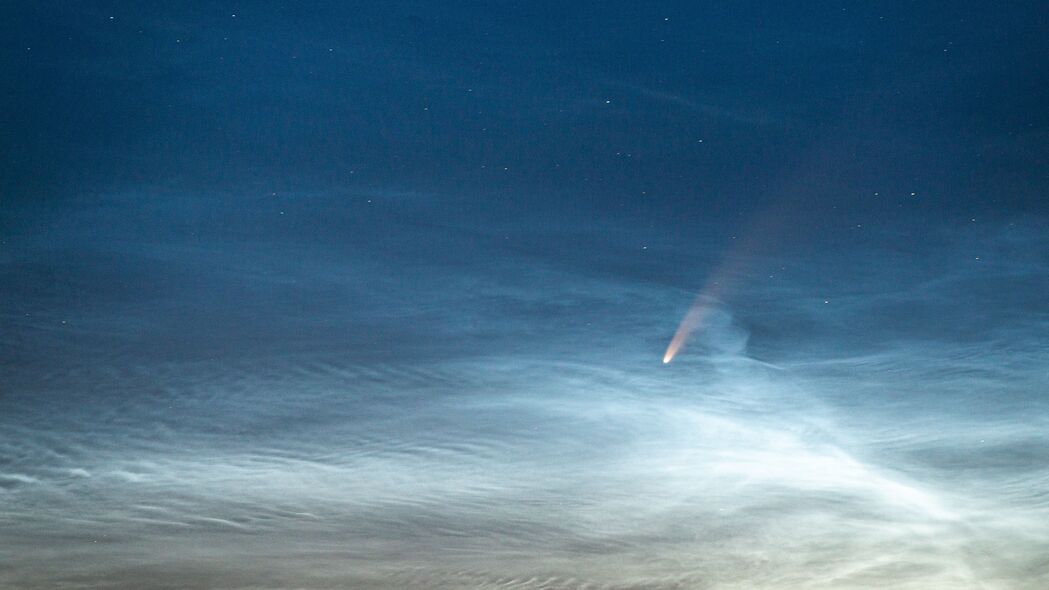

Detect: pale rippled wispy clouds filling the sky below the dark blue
[0,191,1049,589]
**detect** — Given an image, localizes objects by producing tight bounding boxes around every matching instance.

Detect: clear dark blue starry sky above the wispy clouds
[2,2,1049,220]
